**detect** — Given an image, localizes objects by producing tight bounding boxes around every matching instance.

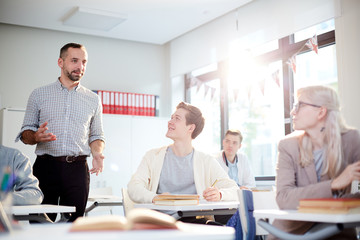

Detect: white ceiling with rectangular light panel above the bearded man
[0,0,253,45]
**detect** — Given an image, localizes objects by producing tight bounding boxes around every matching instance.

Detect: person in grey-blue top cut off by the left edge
[0,144,44,205]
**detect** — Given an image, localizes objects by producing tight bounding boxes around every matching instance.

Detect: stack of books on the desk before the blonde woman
[298,198,360,214]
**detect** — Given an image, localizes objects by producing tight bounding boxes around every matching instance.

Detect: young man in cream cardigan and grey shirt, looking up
[128,102,238,222]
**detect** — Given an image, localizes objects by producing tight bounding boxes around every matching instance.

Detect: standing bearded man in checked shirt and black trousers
[16,43,105,221]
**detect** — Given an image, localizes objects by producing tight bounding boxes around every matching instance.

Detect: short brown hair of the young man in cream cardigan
[176,102,205,139]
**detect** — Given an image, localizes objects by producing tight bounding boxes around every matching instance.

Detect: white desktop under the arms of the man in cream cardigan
[134,200,239,211]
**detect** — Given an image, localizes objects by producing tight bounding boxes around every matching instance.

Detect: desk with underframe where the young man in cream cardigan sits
[134,200,239,219]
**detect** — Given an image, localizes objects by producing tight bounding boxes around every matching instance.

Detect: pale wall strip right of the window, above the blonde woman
[335,0,360,129]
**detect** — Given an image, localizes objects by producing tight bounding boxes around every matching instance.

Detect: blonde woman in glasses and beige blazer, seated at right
[268,86,360,239]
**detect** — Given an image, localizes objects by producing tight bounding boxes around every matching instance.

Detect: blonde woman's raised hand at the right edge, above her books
[331,161,360,190]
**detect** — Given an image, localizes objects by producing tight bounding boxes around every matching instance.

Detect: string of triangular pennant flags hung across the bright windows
[189,34,318,101]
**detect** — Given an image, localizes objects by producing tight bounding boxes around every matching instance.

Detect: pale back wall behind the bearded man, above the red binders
[0,24,171,117]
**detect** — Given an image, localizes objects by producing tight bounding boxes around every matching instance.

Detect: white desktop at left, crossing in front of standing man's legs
[11,204,76,215]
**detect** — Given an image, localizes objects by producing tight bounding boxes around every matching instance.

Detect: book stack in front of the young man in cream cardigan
[154,194,200,206]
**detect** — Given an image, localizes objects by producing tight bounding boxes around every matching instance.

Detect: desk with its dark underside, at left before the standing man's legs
[11,204,76,223]
